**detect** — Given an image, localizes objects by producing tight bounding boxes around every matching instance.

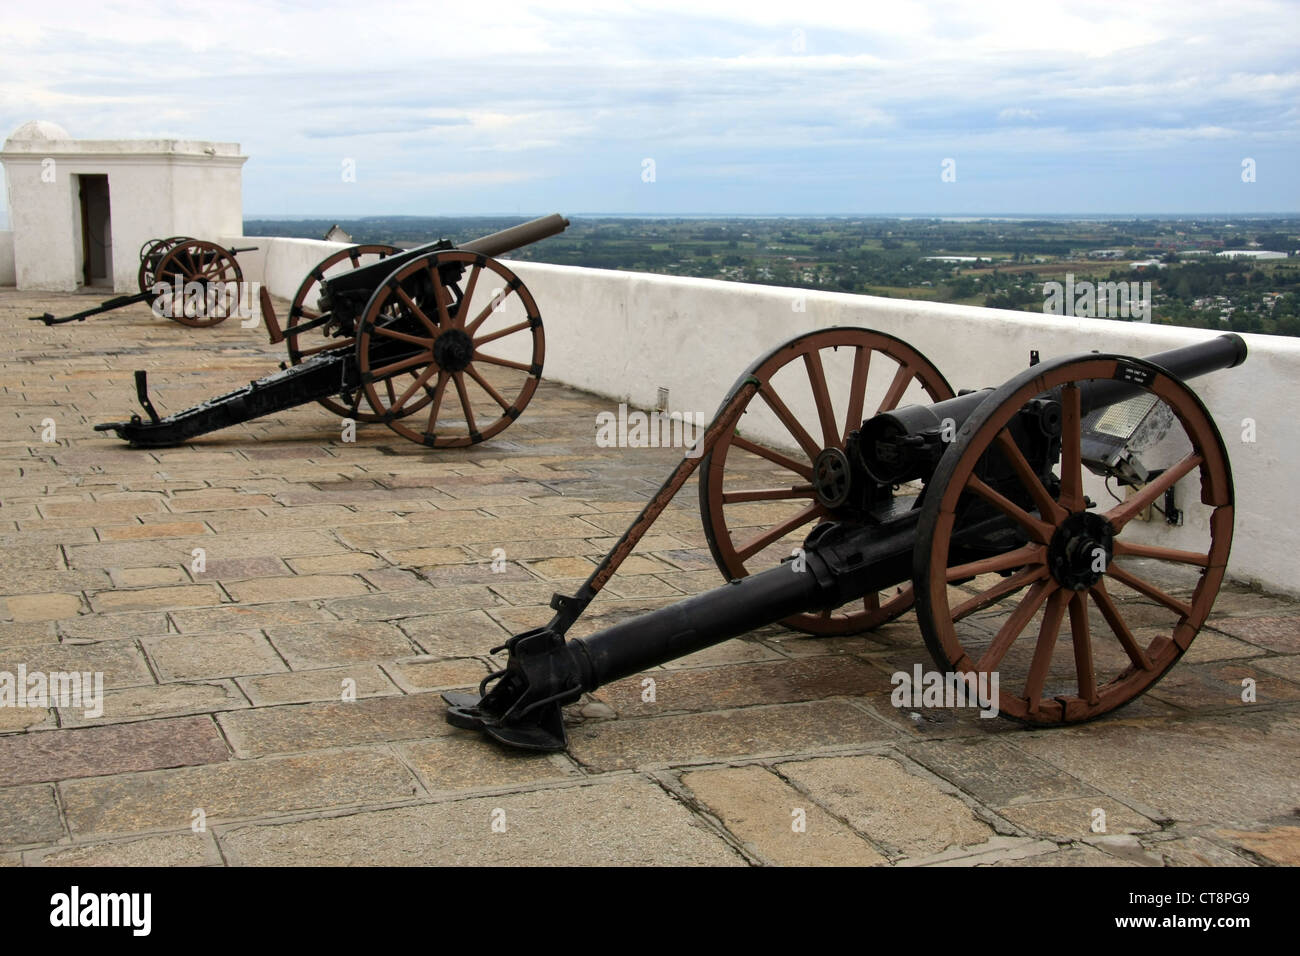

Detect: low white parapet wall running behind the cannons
[226,237,1300,594]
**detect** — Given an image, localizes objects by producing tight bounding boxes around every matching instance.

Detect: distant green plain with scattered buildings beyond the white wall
[244,216,1300,336]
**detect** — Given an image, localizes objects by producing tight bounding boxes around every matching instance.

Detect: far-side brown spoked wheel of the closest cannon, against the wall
[699,328,953,633]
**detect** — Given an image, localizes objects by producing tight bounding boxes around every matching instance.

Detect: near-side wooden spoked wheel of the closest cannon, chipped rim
[913,355,1232,724]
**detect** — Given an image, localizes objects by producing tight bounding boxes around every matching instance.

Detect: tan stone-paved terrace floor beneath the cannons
[0,289,1300,866]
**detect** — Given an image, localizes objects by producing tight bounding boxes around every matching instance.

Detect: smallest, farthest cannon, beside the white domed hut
[29,235,257,328]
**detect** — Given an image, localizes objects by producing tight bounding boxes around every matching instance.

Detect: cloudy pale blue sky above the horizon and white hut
[0,0,1300,222]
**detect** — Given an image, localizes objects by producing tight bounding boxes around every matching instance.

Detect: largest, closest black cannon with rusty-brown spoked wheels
[443,328,1247,750]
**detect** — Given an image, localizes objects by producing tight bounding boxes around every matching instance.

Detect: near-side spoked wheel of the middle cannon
[356,250,546,447]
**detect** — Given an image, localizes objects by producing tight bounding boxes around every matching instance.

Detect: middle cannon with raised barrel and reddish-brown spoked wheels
[95,215,568,447]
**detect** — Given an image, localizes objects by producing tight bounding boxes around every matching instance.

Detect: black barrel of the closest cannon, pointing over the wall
[862,332,1247,483]
